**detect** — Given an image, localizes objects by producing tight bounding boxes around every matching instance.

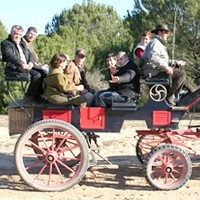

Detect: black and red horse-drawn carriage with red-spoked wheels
[3,70,200,191]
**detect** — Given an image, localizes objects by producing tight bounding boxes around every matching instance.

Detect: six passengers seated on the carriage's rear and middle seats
[1,25,140,107]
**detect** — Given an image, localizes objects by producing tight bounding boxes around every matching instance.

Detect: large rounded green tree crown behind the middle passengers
[45,1,130,69]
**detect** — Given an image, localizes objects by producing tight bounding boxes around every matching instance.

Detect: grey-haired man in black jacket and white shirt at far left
[1,25,43,100]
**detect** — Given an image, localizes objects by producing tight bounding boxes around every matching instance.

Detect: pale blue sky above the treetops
[0,0,134,34]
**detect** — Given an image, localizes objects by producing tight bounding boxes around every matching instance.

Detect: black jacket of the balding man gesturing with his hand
[109,60,140,97]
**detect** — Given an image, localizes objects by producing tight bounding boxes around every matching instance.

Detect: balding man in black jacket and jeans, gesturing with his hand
[95,51,140,107]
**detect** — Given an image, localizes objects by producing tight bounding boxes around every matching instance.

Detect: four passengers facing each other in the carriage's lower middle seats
[41,48,140,107]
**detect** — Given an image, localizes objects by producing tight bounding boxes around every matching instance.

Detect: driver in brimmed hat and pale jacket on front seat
[141,24,186,106]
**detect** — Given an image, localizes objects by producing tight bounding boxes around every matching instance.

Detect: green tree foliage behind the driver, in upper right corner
[125,0,200,81]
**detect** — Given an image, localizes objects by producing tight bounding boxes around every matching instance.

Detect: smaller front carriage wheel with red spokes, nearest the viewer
[144,144,192,190]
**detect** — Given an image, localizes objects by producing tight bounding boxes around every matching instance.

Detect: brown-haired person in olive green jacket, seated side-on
[44,54,88,107]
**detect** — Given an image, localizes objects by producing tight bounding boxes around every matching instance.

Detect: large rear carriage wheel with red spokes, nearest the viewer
[15,120,89,191]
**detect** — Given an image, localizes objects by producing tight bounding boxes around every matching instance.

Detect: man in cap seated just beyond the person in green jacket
[64,48,94,106]
